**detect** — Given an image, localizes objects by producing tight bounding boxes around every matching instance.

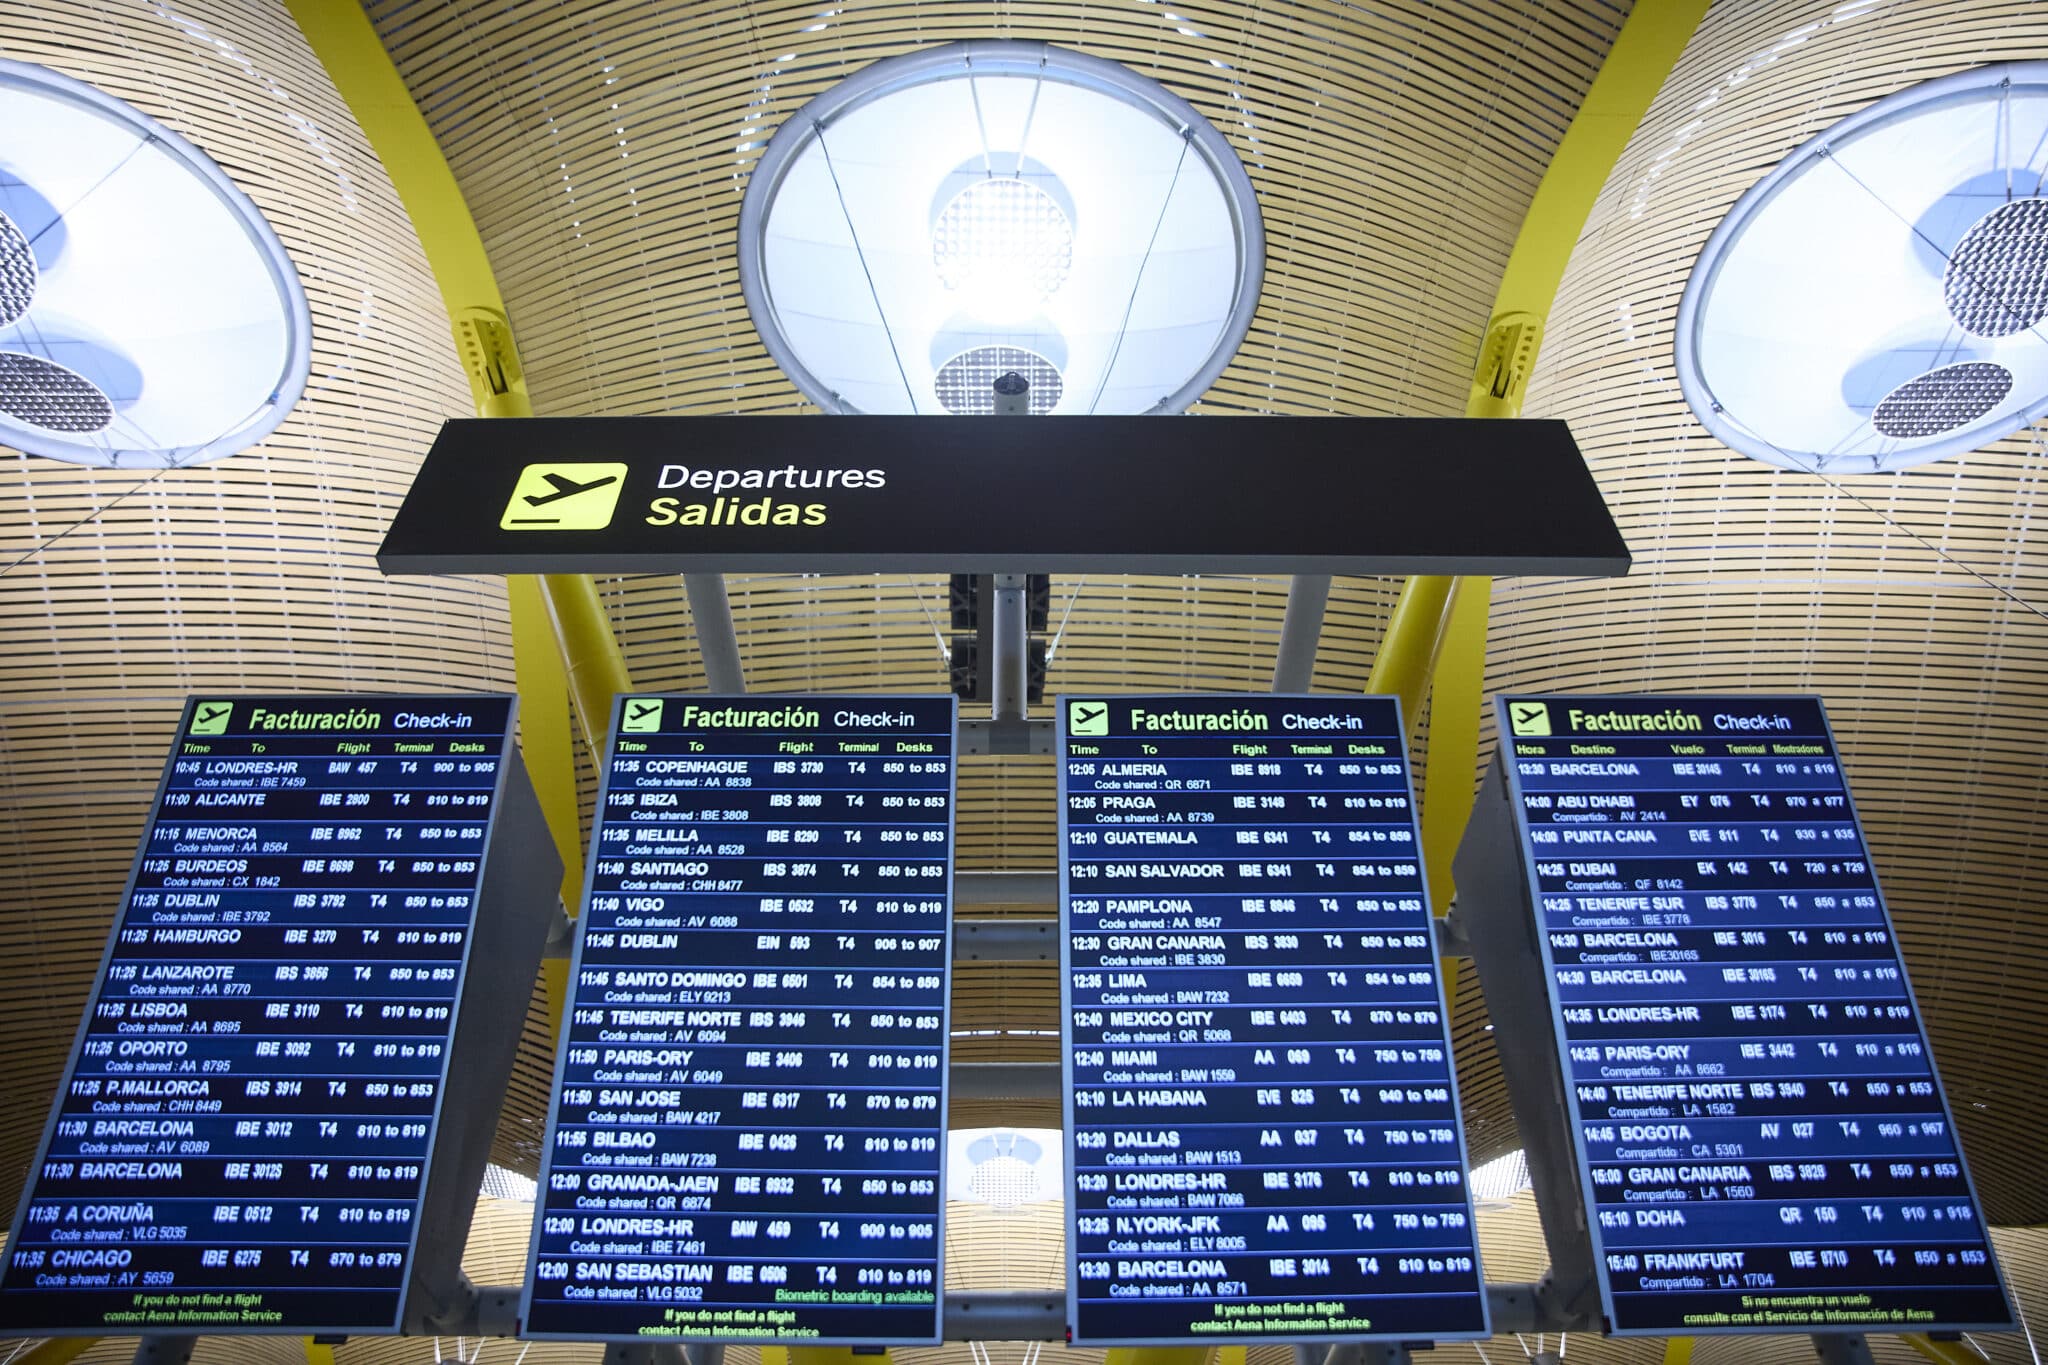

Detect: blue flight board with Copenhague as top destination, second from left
[522,696,954,1345]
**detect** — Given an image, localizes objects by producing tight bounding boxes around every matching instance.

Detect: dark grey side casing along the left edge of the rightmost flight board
[1452,755,1602,1328]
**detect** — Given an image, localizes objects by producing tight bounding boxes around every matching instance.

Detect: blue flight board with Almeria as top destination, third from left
[1059,696,1487,1345]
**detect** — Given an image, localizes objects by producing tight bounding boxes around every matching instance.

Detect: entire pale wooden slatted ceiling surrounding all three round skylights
[0,0,2048,1365]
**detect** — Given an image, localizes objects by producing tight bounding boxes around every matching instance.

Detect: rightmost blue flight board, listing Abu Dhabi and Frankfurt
[1499,696,2011,1334]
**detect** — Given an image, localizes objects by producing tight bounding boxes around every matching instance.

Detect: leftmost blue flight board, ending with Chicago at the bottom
[0,696,526,1334]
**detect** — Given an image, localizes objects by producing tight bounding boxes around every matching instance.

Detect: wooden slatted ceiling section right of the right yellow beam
[1489,2,2048,1222]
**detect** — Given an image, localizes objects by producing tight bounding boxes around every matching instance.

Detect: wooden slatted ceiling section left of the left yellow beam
[0,0,510,1236]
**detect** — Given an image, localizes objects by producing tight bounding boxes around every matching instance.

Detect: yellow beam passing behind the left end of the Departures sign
[287,0,633,1027]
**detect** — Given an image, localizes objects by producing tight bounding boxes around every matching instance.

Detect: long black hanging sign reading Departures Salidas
[377,417,1628,575]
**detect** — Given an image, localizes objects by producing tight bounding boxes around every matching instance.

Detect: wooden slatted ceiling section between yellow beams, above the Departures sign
[369,0,1622,413]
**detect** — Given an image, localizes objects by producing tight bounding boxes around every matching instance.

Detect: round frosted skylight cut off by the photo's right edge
[1675,61,2048,473]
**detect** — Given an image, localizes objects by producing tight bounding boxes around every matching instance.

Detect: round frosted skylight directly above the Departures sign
[739,41,1266,413]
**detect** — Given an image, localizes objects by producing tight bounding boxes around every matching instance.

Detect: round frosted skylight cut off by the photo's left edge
[0,61,311,469]
